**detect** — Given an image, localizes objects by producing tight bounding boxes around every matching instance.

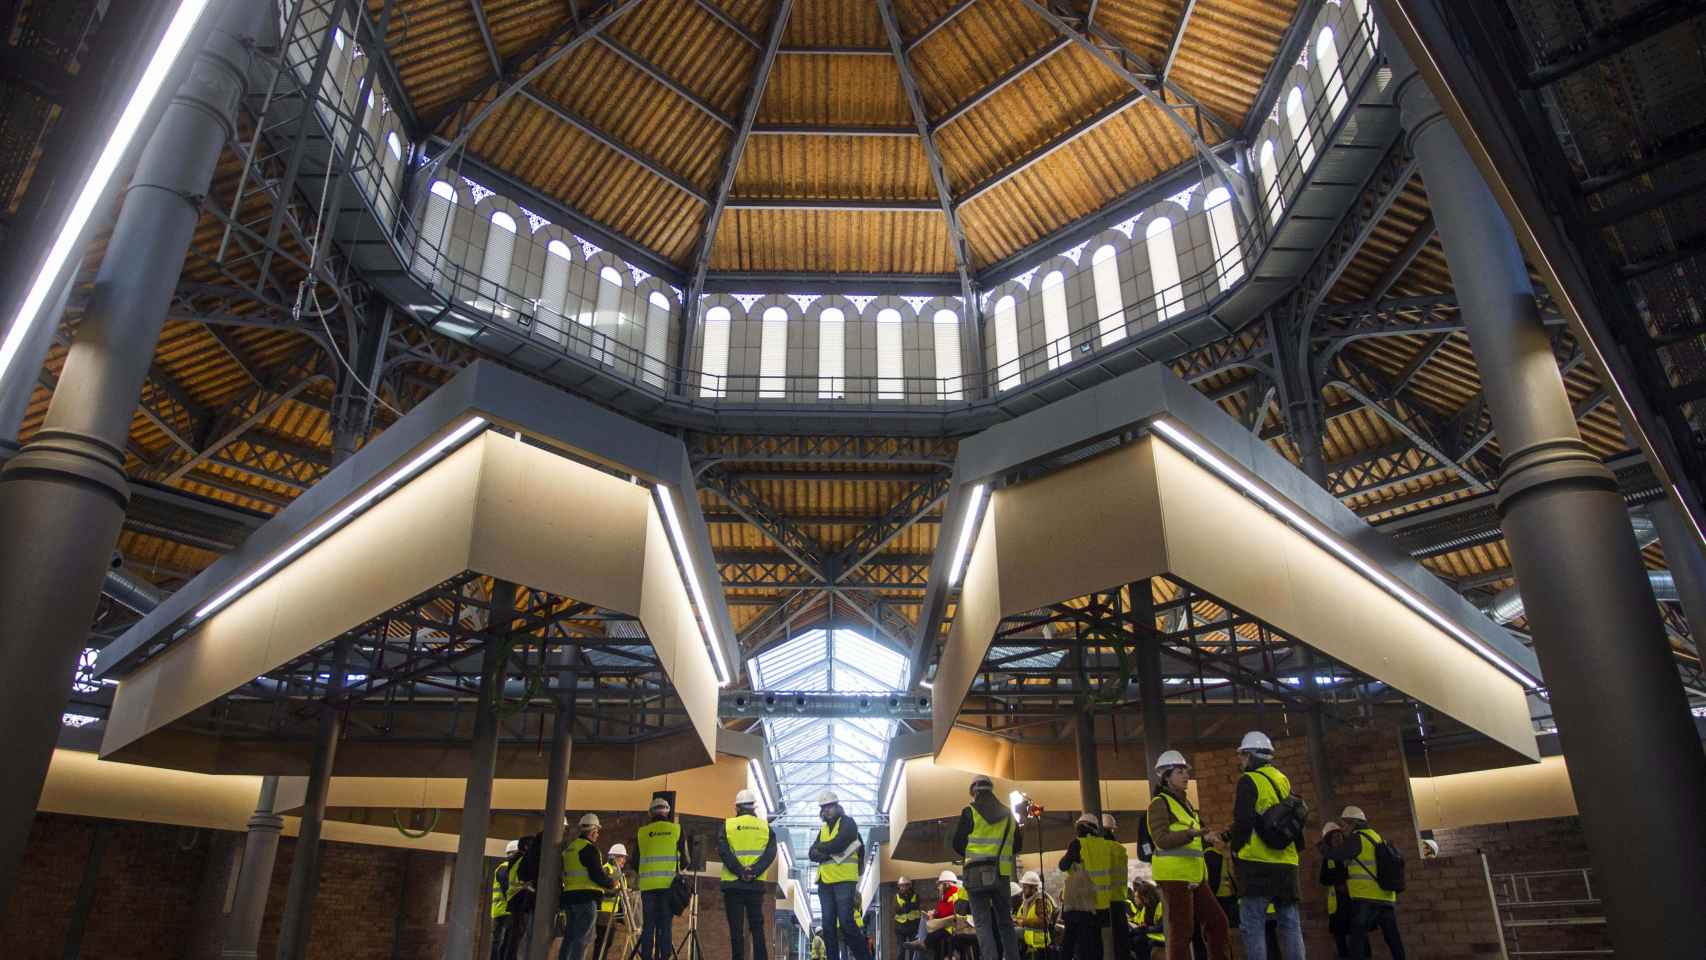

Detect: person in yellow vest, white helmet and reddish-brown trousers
[1148,750,1232,960]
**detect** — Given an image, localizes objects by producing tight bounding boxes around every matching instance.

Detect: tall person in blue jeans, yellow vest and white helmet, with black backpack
[1232,730,1303,960]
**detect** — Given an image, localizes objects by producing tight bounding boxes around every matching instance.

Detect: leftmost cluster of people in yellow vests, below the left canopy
[491,789,777,960]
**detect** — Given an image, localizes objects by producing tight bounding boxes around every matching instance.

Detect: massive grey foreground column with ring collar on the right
[1382,29,1706,957]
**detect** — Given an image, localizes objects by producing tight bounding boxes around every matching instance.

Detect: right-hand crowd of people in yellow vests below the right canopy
[893,732,1404,960]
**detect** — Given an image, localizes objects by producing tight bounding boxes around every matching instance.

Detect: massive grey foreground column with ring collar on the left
[0,0,271,909]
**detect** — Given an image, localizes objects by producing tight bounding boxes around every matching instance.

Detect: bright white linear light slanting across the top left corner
[0,0,220,387]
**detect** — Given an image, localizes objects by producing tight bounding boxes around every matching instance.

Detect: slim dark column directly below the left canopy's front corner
[444,580,515,960]
